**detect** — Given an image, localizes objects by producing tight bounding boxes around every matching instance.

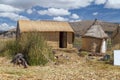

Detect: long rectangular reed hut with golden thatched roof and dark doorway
[17,20,74,48]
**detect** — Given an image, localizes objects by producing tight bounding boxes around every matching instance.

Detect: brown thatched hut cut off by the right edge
[111,25,120,49]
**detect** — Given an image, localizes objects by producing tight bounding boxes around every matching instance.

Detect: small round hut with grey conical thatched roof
[82,24,108,53]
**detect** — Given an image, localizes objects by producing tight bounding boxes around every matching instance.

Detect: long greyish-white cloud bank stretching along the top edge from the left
[0,0,94,9]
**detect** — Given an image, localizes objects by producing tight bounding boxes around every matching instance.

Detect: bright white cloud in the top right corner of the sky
[105,0,120,9]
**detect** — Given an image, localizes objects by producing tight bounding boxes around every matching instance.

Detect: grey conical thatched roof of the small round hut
[84,25,108,38]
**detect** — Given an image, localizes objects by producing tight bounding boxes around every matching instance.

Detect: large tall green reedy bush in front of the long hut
[20,33,53,65]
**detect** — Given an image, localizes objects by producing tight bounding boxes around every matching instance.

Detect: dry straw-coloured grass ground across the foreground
[0,52,120,80]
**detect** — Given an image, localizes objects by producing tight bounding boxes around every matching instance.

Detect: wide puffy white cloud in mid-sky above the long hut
[38,8,71,16]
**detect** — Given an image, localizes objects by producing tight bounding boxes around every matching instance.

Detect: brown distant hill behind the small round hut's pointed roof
[69,20,118,36]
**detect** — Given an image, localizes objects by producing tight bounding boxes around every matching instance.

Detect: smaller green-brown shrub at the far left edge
[0,39,21,58]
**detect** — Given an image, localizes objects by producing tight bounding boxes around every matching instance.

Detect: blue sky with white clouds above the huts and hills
[0,0,120,30]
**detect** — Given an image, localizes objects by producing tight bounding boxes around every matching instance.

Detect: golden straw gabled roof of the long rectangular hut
[18,20,74,32]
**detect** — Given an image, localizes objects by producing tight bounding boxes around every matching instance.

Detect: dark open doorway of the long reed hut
[59,32,67,48]
